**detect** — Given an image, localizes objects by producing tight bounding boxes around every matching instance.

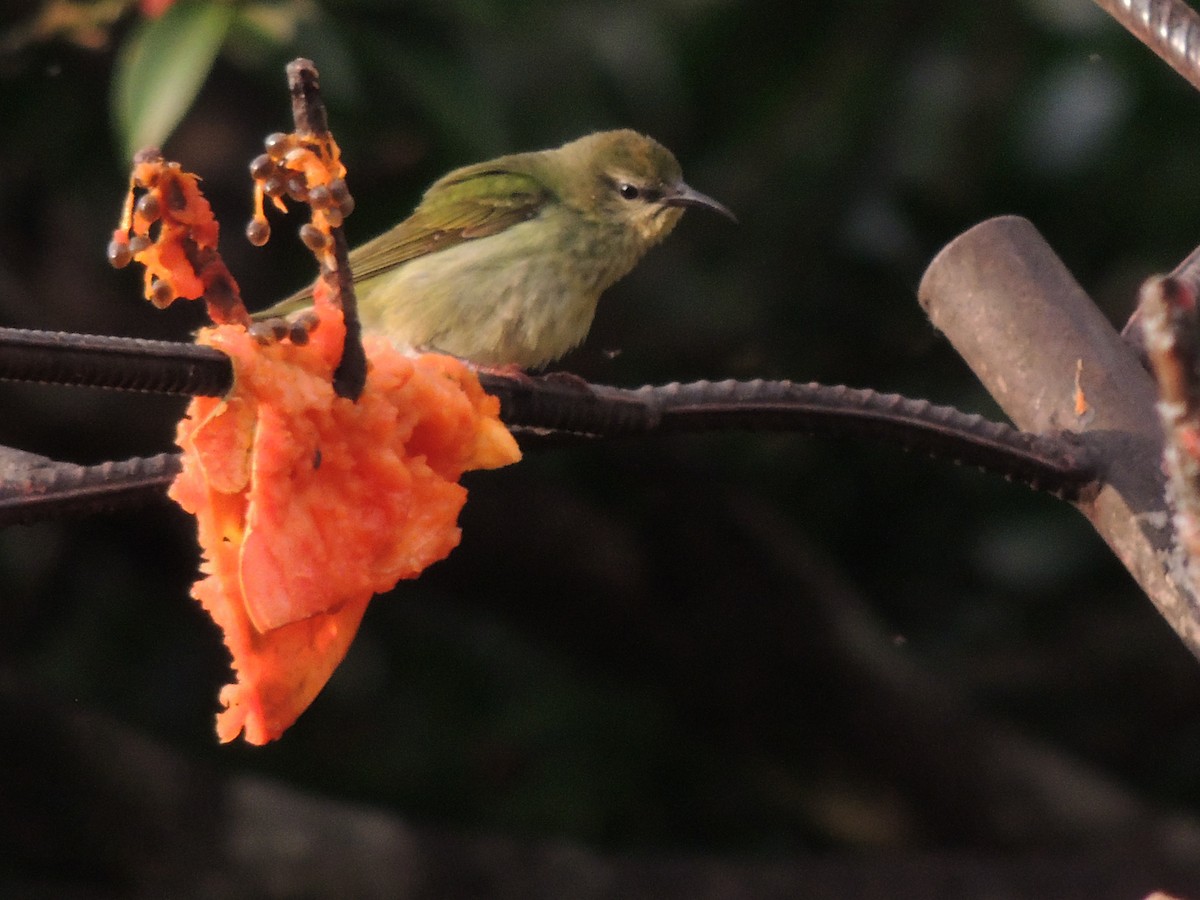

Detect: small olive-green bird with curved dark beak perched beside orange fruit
[256,130,736,368]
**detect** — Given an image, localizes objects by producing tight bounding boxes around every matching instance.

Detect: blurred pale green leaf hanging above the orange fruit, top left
[112,0,234,158]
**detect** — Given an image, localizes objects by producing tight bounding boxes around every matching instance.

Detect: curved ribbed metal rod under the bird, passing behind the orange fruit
[0,376,1096,527]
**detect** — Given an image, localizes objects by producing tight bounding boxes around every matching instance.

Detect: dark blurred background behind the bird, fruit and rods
[0,0,1200,898]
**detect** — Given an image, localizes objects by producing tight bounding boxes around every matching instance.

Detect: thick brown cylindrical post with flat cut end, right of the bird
[919,216,1200,656]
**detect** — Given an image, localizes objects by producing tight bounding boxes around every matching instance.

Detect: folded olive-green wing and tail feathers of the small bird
[256,162,551,318]
